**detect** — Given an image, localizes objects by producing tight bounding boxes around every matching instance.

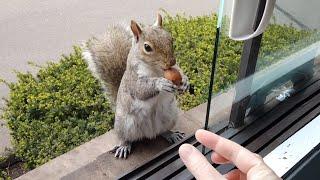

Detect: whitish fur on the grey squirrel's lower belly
[126,92,179,141]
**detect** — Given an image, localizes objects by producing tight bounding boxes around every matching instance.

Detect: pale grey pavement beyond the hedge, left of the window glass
[0,0,218,154]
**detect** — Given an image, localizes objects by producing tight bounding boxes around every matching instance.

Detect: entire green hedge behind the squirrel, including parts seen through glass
[3,15,315,171]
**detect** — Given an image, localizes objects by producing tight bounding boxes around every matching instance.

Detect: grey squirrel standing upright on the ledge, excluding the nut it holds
[83,14,189,158]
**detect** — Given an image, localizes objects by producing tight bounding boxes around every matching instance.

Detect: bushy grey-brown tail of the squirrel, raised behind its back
[82,25,132,107]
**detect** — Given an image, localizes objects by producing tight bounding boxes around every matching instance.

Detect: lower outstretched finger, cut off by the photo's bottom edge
[179,144,224,179]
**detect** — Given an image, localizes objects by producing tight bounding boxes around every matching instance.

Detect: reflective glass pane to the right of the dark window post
[251,0,320,111]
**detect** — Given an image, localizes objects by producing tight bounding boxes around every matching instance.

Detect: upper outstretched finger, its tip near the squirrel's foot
[196,130,263,173]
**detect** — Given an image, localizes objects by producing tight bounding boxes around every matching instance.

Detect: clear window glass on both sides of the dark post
[205,0,320,126]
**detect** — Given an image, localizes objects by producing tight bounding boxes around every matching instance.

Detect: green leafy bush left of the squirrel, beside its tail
[3,48,114,168]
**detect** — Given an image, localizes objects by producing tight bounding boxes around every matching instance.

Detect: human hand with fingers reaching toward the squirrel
[179,130,280,180]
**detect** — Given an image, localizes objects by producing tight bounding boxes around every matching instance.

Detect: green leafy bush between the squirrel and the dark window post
[164,15,242,110]
